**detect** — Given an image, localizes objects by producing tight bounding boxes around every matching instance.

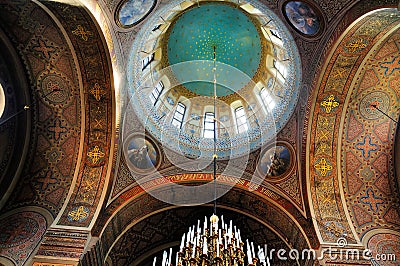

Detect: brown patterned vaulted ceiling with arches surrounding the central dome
[0,0,400,265]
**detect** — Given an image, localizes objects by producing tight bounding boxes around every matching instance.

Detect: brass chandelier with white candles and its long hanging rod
[153,46,271,266]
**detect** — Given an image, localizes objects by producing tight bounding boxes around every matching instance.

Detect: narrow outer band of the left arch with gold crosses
[36,2,114,228]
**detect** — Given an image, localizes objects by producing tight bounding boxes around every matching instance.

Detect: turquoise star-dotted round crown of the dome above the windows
[167,2,262,96]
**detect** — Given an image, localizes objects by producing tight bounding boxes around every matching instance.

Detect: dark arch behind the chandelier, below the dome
[98,184,317,265]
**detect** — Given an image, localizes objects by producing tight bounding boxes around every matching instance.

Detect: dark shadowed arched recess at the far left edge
[0,26,31,209]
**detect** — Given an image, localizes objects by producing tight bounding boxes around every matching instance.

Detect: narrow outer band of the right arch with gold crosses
[306,6,399,245]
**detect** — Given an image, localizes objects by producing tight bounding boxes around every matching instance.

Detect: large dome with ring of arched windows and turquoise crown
[124,1,301,159]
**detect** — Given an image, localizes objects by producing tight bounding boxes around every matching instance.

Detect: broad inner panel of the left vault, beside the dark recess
[1,1,81,216]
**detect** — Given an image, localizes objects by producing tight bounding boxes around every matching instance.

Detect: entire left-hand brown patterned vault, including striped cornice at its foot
[0,1,114,265]
